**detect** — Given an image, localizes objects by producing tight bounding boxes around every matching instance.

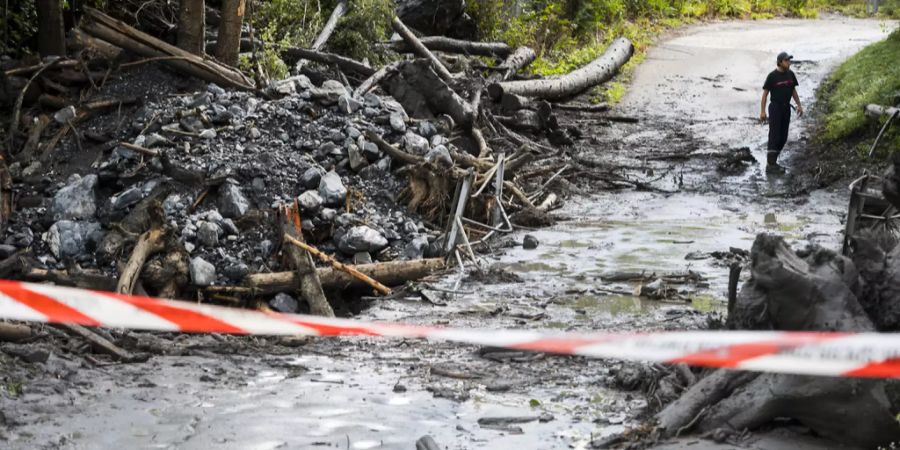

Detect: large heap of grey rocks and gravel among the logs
[5,68,450,292]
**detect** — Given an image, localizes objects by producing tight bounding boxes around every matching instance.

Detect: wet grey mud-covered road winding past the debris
[0,18,893,450]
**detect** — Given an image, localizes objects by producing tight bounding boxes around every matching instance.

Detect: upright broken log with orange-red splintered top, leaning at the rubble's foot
[281,204,334,317]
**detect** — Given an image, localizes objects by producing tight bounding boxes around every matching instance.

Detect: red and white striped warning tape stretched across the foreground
[0,281,900,378]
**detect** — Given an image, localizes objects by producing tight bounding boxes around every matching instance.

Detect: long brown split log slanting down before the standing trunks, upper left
[81,8,255,91]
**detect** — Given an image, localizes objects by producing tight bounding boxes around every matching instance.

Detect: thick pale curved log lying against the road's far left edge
[488,38,634,100]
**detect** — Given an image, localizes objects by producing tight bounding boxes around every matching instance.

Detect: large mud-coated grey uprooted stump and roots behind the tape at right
[657,235,900,448]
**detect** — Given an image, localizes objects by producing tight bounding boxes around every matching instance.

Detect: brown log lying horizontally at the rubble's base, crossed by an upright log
[244,258,445,295]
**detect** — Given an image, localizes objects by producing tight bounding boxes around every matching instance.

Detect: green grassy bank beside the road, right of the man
[819,30,900,148]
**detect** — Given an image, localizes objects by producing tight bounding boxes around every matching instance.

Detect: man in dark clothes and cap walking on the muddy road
[759,52,803,171]
